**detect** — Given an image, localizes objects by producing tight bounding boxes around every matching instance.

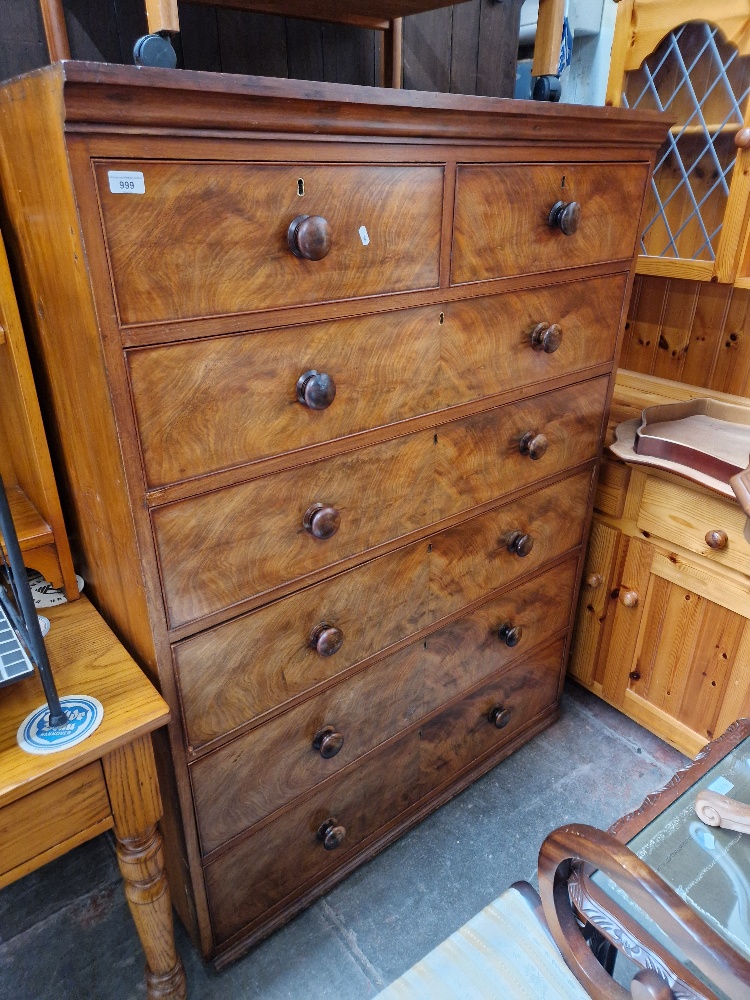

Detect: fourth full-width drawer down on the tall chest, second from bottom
[191,557,577,853]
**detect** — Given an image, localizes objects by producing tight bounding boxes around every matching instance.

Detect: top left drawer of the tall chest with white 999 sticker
[96,160,444,325]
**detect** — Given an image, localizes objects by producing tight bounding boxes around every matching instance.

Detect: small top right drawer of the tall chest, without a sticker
[451,163,648,284]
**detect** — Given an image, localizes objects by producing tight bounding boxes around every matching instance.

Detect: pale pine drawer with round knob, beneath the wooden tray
[638,476,750,574]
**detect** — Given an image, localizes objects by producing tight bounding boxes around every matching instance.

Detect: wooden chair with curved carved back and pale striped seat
[376,825,750,1000]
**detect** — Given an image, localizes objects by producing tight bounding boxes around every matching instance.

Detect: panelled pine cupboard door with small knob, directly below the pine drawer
[602,538,750,757]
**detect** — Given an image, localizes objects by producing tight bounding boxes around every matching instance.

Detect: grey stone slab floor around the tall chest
[0,685,685,1000]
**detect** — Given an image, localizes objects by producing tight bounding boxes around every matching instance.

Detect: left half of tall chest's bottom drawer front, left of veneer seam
[205,737,420,941]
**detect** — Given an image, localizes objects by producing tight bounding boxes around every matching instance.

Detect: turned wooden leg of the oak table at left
[102,736,187,1000]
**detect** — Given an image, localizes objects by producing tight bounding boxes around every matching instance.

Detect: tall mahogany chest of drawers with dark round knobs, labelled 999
[0,63,667,965]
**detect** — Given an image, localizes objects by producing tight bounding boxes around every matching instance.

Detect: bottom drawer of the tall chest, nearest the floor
[205,642,563,942]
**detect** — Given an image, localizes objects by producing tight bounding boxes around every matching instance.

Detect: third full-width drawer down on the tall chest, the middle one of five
[173,472,591,748]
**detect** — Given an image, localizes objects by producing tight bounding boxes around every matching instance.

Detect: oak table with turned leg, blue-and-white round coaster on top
[0,597,187,1000]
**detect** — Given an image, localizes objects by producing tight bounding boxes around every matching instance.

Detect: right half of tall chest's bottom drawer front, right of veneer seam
[419,640,565,791]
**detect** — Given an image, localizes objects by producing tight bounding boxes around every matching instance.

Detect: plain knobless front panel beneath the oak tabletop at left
[0,761,112,885]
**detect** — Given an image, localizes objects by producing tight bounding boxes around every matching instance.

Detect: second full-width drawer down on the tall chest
[152,377,608,627]
